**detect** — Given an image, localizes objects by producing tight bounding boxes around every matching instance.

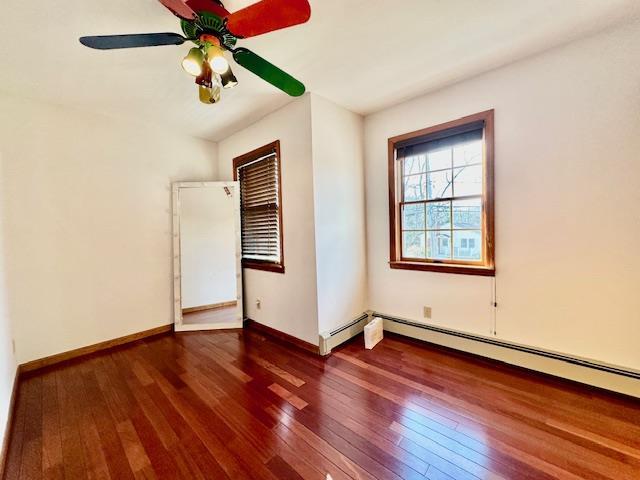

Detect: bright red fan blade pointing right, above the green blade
[227,0,311,38]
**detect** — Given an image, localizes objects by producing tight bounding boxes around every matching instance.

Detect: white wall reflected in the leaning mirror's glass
[180,187,237,308]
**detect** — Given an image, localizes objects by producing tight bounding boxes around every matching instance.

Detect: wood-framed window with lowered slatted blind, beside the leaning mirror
[233,141,284,273]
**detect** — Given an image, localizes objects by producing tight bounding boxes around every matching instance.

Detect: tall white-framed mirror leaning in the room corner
[173,182,242,331]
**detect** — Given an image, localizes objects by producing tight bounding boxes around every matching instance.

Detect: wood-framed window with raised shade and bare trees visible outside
[389,110,495,275]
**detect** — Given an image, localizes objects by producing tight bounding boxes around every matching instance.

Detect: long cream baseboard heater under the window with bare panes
[371,312,640,397]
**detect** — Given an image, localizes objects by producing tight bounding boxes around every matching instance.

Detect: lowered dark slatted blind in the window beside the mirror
[237,152,280,262]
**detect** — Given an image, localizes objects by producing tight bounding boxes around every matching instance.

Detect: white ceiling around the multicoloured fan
[0,0,640,140]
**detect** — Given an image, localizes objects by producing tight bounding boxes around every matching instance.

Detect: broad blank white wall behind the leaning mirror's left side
[0,96,216,363]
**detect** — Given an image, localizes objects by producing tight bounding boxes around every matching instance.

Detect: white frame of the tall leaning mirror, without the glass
[172,182,243,332]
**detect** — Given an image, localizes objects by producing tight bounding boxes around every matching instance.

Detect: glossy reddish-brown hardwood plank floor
[6,331,640,480]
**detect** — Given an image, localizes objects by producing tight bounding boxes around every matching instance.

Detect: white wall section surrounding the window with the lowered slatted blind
[218,95,318,345]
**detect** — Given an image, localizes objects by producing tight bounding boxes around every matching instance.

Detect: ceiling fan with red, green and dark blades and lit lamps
[80,0,311,104]
